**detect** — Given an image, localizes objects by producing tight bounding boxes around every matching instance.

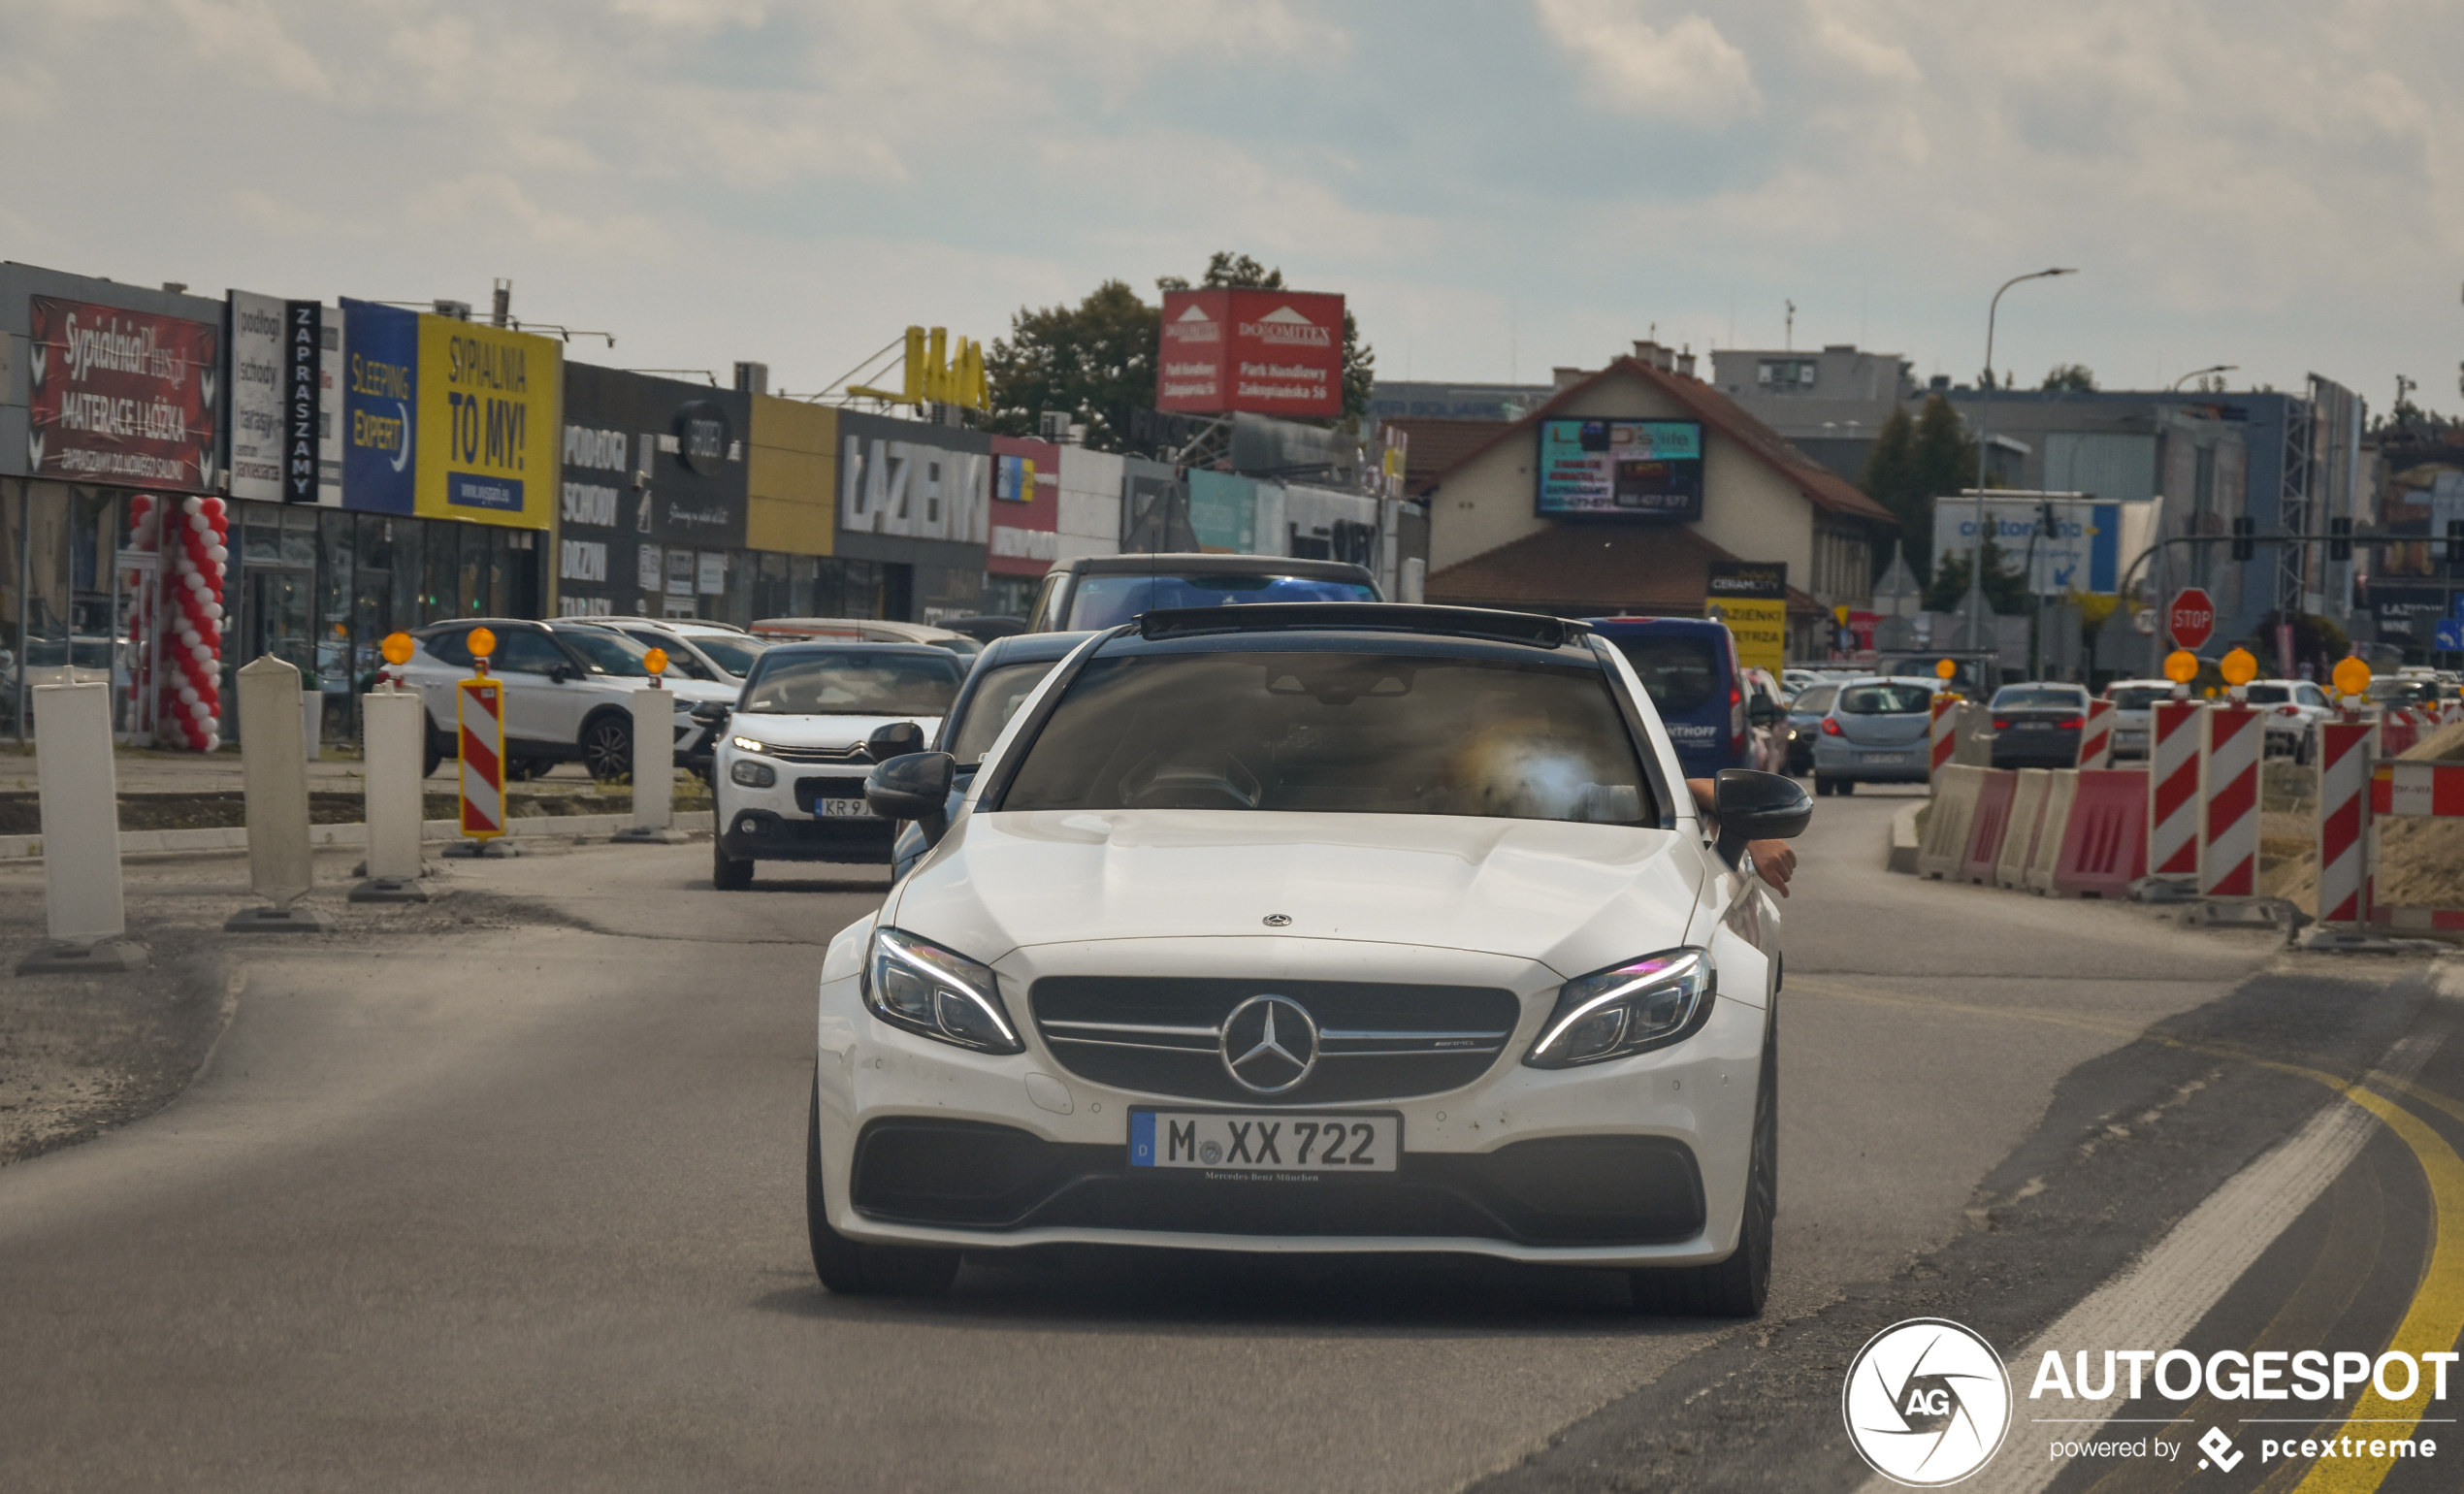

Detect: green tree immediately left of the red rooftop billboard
[983,281,1163,451]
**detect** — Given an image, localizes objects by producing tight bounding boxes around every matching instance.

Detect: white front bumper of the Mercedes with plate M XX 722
[818,925,1765,1265]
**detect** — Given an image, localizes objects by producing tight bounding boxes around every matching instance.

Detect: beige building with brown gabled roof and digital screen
[1419,342,1895,656]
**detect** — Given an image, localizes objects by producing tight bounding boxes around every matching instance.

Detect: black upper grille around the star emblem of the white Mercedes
[1027,976,1523,1104]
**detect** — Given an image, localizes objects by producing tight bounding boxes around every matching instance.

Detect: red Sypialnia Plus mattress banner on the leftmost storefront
[24,296,222,493]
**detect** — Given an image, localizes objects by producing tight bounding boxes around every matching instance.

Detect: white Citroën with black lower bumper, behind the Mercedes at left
[702,643,966,893]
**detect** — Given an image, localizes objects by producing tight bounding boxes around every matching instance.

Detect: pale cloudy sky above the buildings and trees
[0,0,2464,409]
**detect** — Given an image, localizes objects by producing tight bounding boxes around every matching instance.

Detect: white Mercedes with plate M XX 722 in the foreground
[808,601,1811,1314]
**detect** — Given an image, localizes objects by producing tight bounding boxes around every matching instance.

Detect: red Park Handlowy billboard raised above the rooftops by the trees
[1155,291,1343,419]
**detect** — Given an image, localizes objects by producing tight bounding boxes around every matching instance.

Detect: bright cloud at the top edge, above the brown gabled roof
[1533,0,1762,123]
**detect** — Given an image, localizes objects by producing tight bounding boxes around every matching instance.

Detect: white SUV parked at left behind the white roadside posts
[402,616,734,782]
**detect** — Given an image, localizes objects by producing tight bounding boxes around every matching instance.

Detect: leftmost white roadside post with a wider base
[17,683,146,976]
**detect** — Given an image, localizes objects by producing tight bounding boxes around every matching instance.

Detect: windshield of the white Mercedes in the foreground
[1000,653,1658,826]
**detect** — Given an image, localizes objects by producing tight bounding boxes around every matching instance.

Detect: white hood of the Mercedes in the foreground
[885,809,1702,976]
